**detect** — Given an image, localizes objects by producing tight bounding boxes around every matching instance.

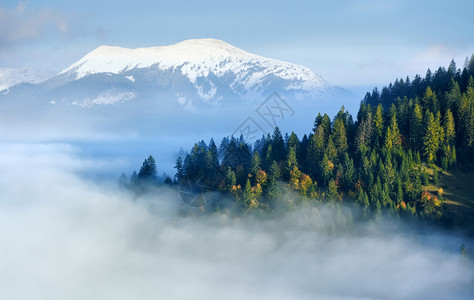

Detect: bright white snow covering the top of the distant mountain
[60,39,330,99]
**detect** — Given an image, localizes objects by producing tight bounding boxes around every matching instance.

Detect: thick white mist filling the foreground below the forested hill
[0,144,474,300]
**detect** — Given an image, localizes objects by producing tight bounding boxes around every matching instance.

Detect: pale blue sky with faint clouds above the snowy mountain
[0,0,474,88]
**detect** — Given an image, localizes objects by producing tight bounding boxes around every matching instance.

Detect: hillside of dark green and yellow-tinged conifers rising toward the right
[125,55,474,230]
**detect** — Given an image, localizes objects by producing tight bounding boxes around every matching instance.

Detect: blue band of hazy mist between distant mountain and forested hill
[0,95,359,177]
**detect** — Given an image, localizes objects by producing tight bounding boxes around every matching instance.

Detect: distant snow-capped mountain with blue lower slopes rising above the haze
[0,39,347,110]
